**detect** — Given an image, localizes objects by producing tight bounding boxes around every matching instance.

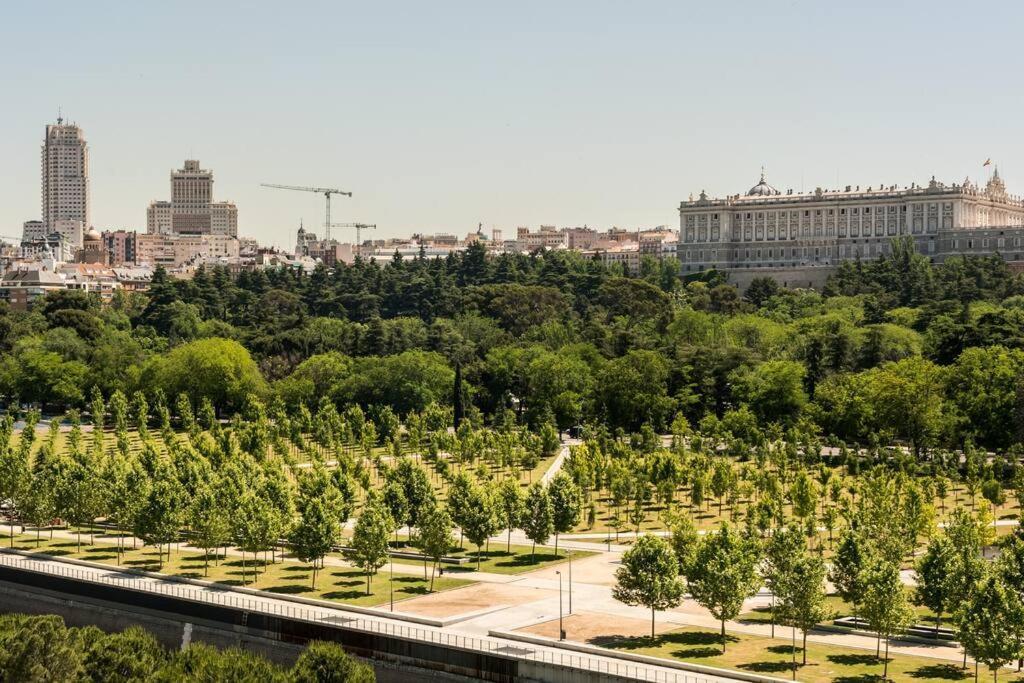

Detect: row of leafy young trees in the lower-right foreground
[613,499,1024,678]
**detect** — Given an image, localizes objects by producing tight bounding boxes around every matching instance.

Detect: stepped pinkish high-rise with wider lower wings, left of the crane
[145,159,239,237]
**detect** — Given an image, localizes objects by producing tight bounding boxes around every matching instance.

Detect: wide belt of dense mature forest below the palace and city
[0,241,1024,456]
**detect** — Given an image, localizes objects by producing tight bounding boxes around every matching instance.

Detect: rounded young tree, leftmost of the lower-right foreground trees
[611,535,683,638]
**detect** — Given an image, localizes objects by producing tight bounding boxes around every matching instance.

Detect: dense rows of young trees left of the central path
[0,385,582,593]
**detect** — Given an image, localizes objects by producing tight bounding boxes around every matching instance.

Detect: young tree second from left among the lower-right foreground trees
[686,522,760,652]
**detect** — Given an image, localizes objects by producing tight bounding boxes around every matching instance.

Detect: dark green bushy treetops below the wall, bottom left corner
[0,614,376,683]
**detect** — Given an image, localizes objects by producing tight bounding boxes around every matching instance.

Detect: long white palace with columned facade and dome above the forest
[677,169,1024,289]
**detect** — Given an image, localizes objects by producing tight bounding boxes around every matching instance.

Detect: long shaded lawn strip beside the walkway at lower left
[5,535,472,606]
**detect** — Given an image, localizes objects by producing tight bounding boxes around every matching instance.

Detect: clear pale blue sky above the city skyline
[0,0,1024,247]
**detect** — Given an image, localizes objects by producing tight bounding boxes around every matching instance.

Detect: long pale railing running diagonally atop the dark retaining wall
[0,552,728,683]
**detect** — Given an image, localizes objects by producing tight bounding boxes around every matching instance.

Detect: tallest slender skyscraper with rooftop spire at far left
[42,117,89,232]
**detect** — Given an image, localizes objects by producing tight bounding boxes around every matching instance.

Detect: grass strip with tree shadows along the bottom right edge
[590,627,1022,683]
